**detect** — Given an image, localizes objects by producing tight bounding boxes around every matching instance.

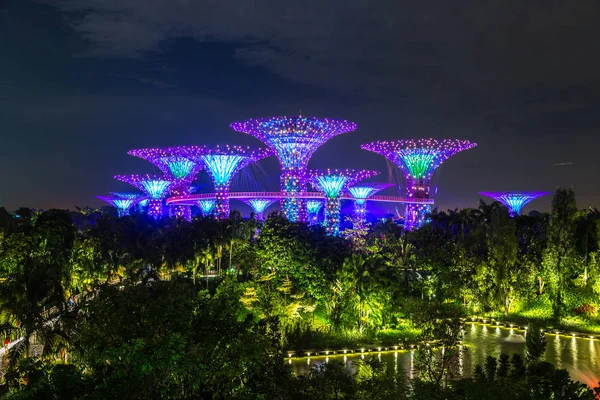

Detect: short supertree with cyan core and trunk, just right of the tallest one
[309,169,379,236]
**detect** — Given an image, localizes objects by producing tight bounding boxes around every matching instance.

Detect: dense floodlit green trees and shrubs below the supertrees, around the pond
[0,190,600,399]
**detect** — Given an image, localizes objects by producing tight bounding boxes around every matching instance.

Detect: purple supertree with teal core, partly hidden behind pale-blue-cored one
[127,146,202,221]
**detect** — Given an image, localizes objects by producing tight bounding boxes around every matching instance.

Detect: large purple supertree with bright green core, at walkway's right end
[361,139,477,230]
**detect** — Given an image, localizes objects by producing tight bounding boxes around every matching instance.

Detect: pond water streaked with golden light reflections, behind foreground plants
[291,324,600,385]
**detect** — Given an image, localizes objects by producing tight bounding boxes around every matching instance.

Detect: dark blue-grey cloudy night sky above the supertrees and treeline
[0,0,600,216]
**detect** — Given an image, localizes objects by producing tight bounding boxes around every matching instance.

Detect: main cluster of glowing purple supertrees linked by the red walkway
[95,114,492,235]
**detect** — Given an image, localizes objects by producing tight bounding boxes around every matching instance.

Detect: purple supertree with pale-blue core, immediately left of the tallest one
[182,145,273,218]
